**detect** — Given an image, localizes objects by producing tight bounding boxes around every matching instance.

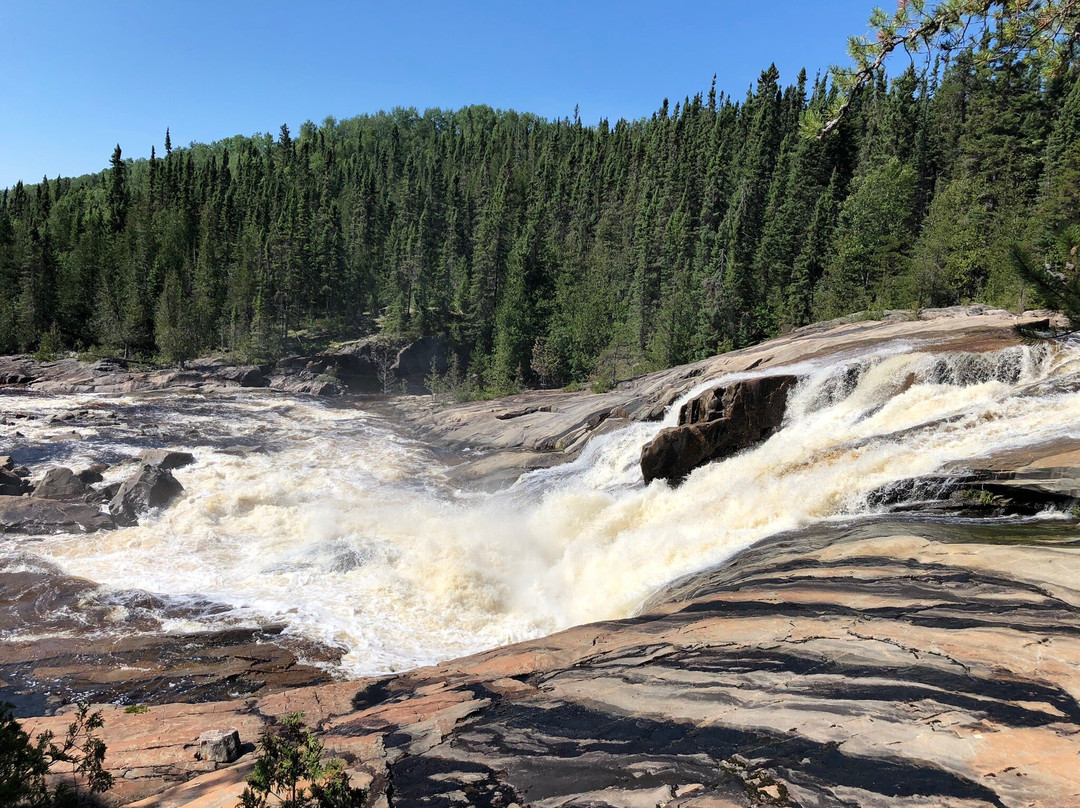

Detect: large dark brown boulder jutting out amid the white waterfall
[640,376,798,484]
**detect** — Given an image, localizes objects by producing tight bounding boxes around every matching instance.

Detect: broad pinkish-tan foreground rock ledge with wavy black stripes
[21,519,1080,808]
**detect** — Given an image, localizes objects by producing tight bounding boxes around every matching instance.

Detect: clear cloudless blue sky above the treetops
[0,0,875,188]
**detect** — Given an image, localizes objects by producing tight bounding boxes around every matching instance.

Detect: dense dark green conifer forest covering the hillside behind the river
[0,53,1080,392]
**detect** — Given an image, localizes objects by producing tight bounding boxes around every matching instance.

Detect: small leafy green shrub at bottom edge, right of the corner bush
[237,713,366,808]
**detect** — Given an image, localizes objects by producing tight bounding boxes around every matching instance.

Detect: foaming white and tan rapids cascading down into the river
[6,344,1080,674]
